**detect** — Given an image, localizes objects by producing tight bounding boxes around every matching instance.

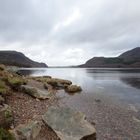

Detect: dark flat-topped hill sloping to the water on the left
[0,51,47,67]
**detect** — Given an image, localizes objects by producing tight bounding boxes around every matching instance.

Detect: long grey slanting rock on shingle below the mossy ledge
[21,85,52,99]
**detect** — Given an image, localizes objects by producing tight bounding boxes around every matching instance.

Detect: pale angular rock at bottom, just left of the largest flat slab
[12,121,42,140]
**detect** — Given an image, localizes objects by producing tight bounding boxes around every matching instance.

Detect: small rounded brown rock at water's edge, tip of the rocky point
[65,85,82,93]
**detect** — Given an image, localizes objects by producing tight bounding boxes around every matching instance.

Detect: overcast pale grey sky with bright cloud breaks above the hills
[0,0,140,66]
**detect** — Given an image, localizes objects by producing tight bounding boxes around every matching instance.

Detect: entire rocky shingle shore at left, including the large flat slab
[0,65,96,140]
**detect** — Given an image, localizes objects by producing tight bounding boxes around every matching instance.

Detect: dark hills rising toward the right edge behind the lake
[79,47,140,68]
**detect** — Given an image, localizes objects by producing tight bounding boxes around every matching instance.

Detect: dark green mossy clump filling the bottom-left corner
[0,128,15,140]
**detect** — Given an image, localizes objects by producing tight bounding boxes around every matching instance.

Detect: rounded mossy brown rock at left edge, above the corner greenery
[0,104,14,128]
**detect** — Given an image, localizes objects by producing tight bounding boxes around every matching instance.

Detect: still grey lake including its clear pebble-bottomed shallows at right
[20,68,140,140]
